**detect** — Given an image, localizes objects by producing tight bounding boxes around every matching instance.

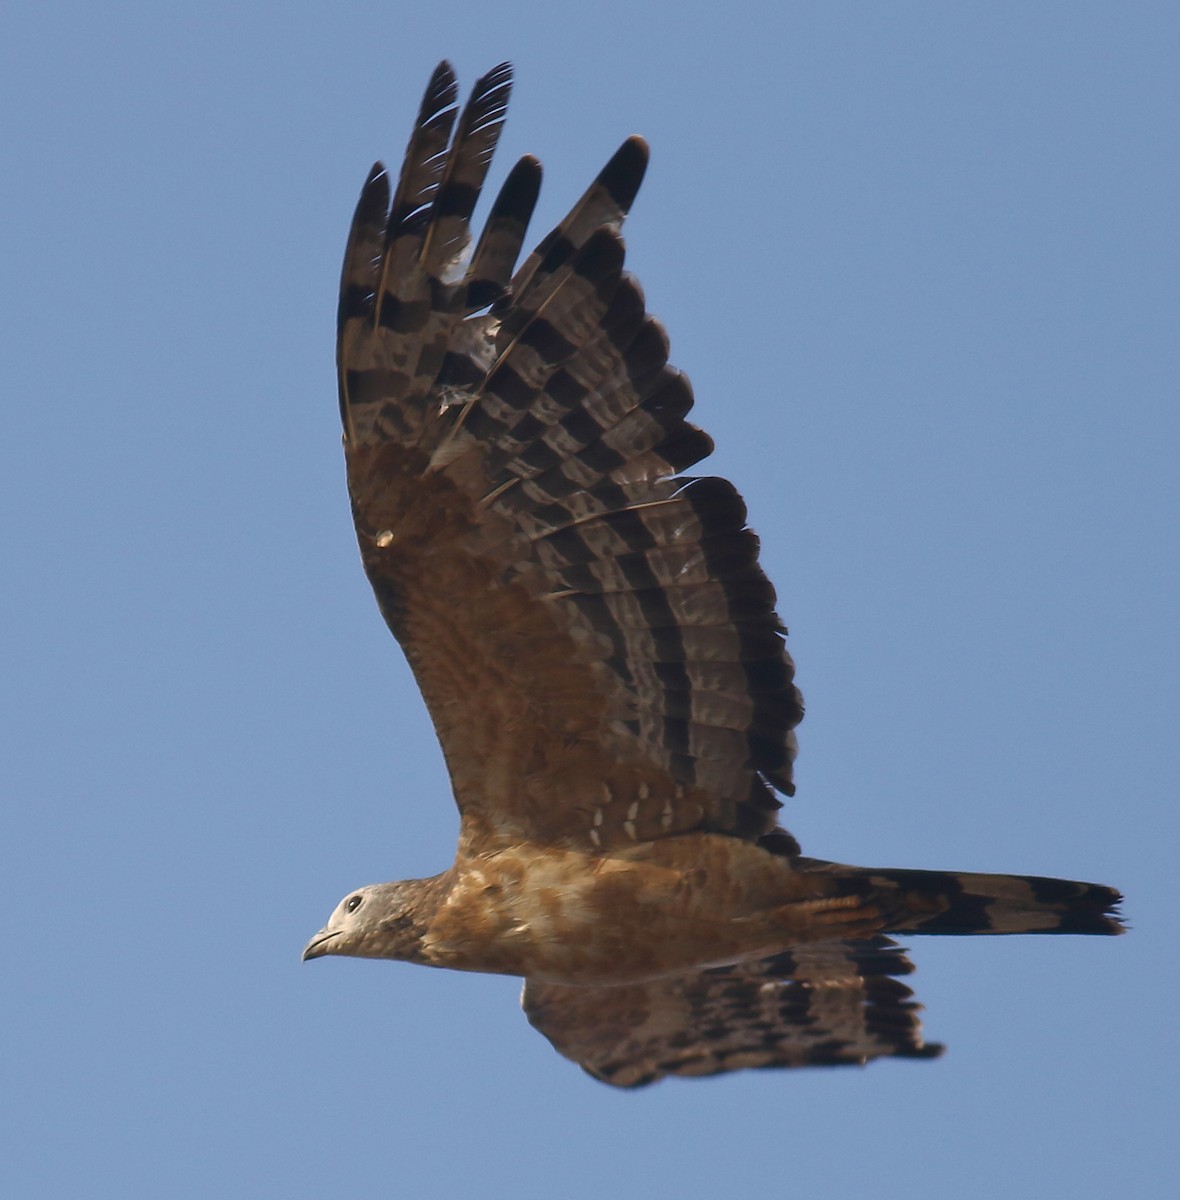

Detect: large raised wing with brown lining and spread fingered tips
[339,62,802,848]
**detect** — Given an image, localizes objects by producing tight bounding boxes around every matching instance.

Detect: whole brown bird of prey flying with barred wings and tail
[304,62,1122,1087]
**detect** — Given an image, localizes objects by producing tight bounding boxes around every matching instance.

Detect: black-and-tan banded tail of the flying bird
[801,864,1126,934]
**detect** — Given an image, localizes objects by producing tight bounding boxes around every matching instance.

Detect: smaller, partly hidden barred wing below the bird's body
[521,936,942,1087]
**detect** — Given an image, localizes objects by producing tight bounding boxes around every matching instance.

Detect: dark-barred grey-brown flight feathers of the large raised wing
[340,65,802,836]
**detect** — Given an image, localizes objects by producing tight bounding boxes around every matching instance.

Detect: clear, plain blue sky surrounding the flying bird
[0,0,1180,1200]
